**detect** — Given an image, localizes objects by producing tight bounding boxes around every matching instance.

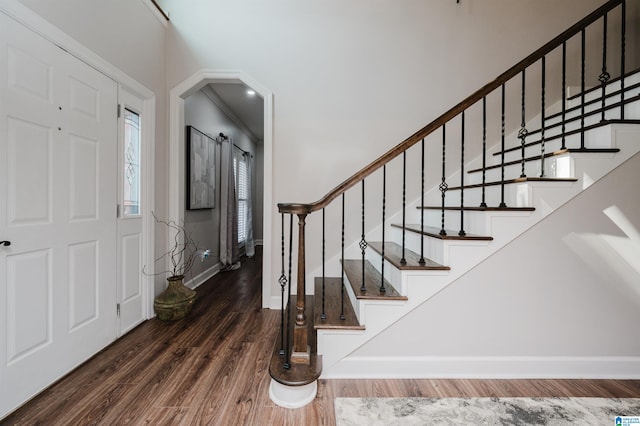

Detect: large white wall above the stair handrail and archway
[167,0,616,306]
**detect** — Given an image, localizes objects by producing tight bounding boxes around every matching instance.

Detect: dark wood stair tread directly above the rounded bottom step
[313,277,364,330]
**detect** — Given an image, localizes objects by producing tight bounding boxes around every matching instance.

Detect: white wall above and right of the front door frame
[14,0,168,293]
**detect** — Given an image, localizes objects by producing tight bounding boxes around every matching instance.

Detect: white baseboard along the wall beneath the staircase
[321,357,640,380]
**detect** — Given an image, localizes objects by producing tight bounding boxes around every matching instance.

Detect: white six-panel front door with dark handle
[0,12,117,418]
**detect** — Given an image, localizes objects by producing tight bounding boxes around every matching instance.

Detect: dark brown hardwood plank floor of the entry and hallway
[0,245,640,425]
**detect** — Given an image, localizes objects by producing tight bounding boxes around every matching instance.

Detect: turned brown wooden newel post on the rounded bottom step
[291,213,311,364]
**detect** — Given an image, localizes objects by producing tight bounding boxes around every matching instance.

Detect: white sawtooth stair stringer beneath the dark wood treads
[317,124,640,378]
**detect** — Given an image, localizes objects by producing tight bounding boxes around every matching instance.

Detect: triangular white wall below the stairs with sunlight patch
[353,155,640,366]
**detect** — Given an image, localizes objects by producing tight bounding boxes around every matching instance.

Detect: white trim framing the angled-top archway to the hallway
[169,69,273,308]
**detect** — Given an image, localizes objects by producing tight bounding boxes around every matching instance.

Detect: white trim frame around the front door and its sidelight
[0,0,156,319]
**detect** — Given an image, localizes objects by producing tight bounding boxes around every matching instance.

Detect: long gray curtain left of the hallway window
[220,139,240,270]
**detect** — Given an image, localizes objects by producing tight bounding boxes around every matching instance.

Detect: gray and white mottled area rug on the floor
[335,398,640,426]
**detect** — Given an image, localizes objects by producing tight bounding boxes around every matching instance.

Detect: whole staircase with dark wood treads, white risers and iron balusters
[270,0,640,402]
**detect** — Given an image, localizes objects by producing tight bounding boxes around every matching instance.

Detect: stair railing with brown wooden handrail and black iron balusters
[274,0,638,379]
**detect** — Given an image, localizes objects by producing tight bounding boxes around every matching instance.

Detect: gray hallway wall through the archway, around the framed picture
[184,91,262,276]
